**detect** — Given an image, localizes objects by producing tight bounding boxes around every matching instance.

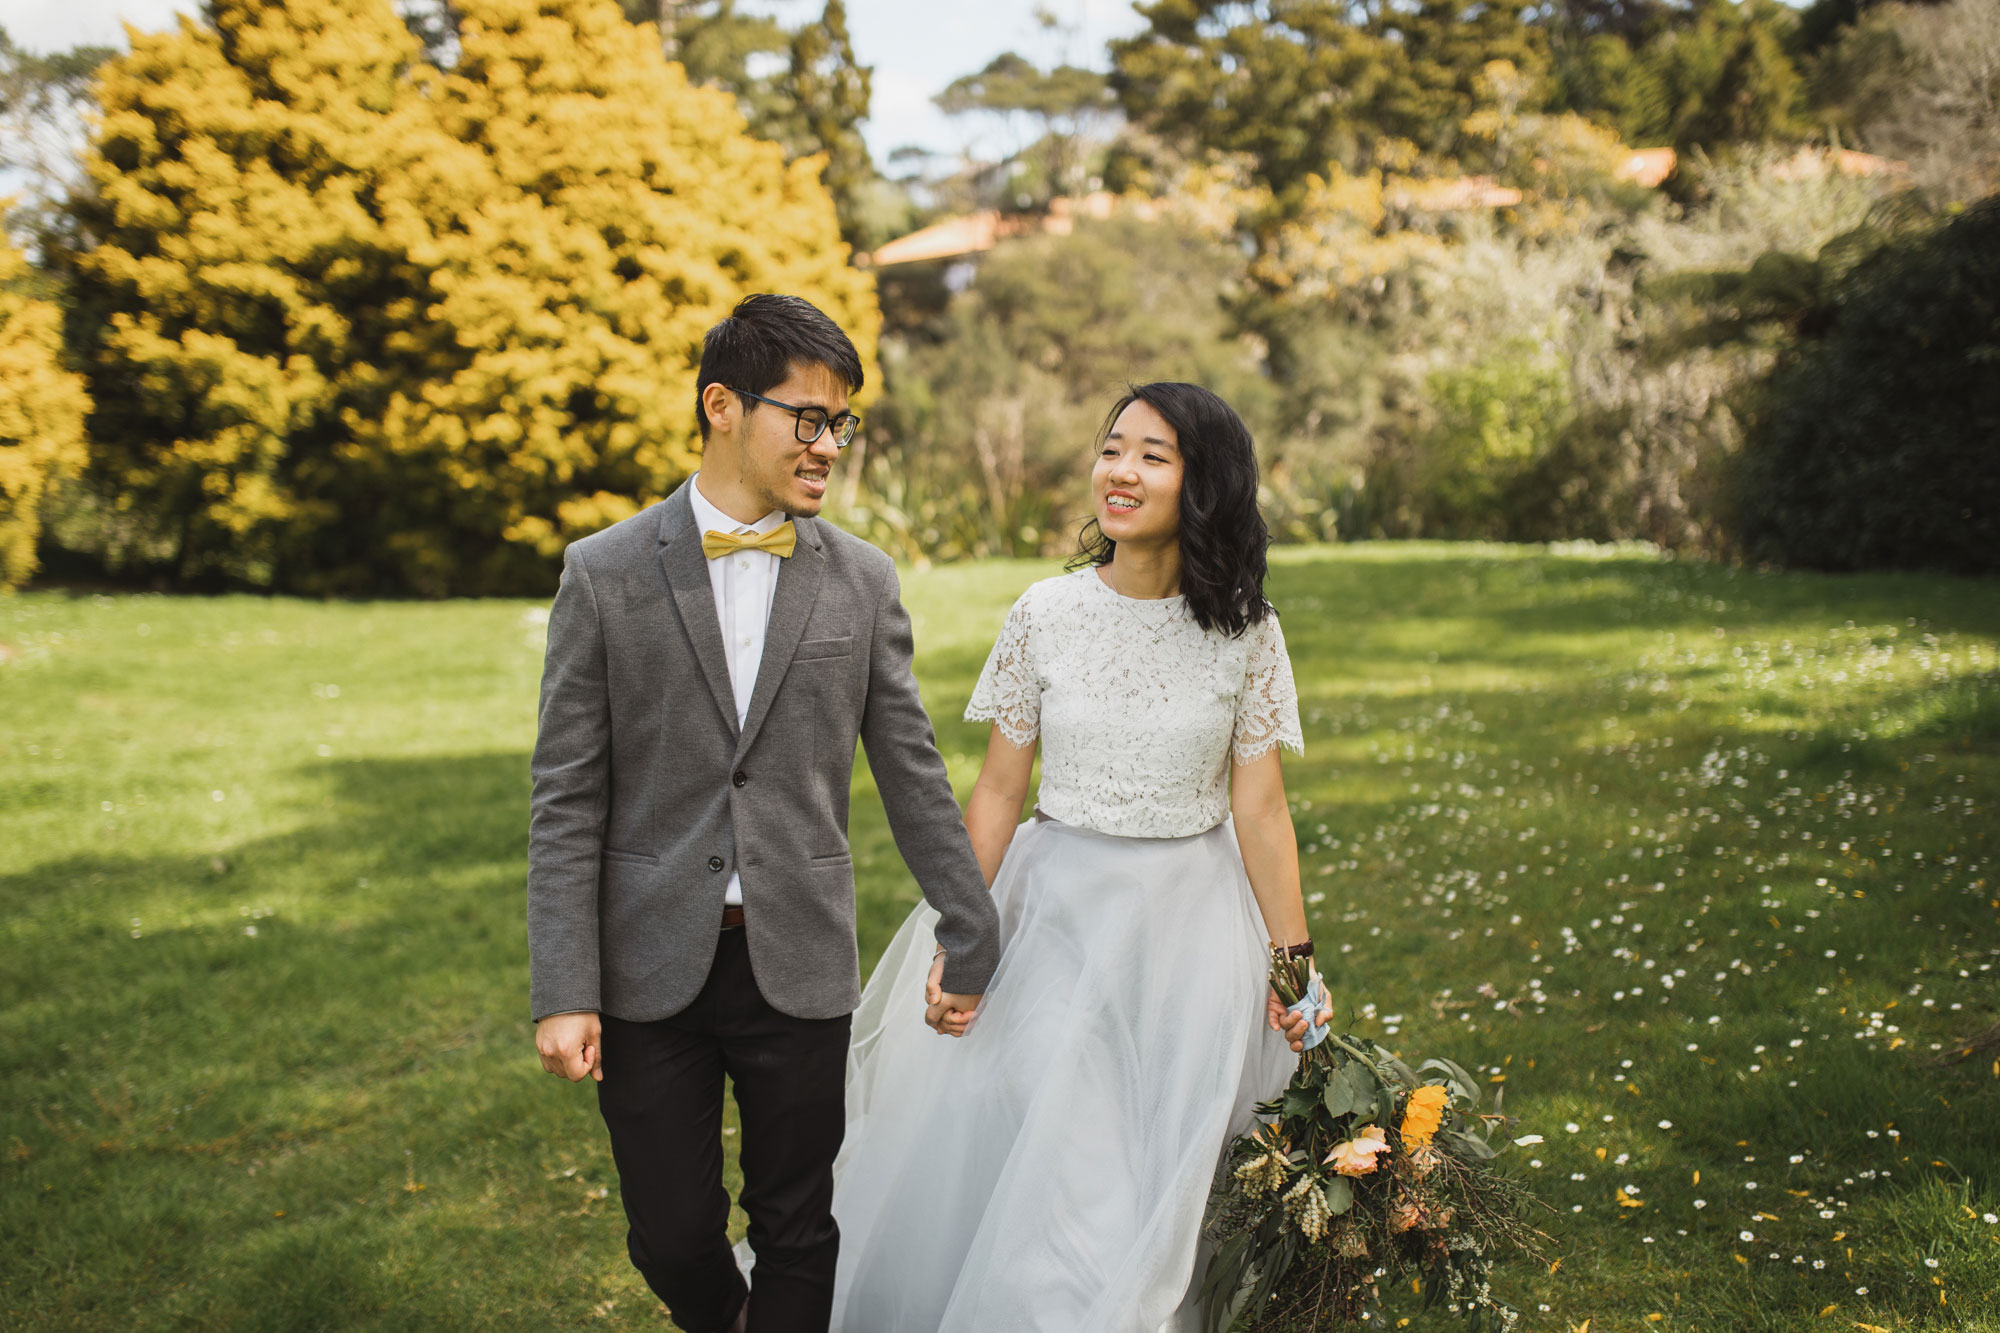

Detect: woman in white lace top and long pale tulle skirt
[834,384,1326,1333]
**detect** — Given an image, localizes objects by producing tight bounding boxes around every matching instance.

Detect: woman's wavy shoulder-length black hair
[1068,380,1270,638]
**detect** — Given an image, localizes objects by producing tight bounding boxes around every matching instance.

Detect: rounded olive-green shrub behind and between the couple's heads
[838,212,1270,560]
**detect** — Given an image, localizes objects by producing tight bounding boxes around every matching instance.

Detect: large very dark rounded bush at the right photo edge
[1736,198,2000,574]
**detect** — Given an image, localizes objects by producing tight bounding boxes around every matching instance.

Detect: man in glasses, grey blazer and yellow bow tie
[528,296,1000,1333]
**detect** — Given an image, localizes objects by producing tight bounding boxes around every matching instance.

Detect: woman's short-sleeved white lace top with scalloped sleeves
[966,566,1306,839]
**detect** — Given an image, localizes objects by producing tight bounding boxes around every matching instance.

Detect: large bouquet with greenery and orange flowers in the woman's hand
[1202,949,1546,1333]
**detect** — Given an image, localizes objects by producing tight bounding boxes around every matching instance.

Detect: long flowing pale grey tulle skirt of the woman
[834,821,1296,1333]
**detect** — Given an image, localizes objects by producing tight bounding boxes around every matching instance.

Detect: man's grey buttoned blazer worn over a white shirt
[528,482,1000,1021]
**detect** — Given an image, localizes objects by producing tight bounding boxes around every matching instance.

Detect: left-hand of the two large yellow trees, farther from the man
[68,0,420,584]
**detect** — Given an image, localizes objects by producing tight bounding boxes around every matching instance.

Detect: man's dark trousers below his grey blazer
[598,929,852,1333]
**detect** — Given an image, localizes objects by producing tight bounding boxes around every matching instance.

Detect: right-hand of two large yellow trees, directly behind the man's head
[360,0,878,590]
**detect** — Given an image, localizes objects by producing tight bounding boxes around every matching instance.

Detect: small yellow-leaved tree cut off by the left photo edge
[0,226,84,590]
